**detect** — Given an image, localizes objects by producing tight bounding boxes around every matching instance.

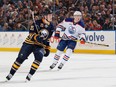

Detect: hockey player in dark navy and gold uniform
[6,9,54,81]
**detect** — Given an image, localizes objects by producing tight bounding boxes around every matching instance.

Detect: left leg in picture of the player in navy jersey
[6,43,33,80]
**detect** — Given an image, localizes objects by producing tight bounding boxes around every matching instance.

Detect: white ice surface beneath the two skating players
[0,52,116,87]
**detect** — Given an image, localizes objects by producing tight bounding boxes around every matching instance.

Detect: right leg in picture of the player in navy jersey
[26,47,45,81]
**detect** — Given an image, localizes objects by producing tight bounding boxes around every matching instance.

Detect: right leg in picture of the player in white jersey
[58,41,76,69]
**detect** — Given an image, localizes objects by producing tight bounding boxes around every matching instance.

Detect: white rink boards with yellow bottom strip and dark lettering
[0,31,116,54]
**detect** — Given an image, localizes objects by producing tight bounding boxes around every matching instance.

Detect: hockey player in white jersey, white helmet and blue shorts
[50,11,85,69]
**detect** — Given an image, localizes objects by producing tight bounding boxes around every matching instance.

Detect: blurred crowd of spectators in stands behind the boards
[0,0,116,31]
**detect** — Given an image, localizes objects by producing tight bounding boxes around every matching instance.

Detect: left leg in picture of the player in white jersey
[50,40,67,69]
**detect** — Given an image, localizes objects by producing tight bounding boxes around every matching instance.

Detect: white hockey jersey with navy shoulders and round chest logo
[56,18,85,40]
